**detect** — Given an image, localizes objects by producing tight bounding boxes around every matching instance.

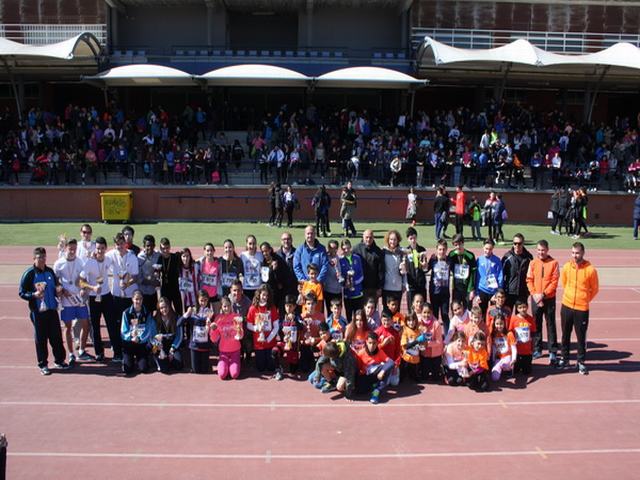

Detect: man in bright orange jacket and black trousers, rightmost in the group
[558,242,599,375]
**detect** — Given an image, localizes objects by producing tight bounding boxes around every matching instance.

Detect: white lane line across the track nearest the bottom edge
[7,448,640,463]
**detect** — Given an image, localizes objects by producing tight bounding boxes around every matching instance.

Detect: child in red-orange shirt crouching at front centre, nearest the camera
[356,332,395,404]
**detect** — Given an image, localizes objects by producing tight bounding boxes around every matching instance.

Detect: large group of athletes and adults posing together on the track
[19,224,598,403]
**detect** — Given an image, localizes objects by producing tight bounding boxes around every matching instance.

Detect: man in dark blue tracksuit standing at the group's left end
[18,247,68,375]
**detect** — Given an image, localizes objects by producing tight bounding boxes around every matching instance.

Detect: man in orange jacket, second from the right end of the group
[527,240,560,365]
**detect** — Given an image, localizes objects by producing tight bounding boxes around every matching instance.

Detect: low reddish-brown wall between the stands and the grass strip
[0,186,634,226]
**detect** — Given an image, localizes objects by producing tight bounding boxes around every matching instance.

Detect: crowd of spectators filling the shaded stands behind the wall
[0,102,640,191]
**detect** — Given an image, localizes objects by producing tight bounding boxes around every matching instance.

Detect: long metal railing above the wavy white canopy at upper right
[411,27,640,54]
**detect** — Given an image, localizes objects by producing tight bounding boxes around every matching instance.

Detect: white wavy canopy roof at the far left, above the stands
[0,32,100,60]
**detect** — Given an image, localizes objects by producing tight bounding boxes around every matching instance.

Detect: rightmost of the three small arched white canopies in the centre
[316,67,426,88]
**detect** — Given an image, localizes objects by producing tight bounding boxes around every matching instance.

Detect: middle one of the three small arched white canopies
[199,64,311,87]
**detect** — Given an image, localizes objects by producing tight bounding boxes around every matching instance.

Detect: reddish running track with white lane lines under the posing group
[0,247,640,479]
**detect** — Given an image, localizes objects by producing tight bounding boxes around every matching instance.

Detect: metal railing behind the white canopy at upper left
[0,23,107,46]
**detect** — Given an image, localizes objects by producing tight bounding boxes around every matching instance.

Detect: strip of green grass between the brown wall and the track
[0,222,640,249]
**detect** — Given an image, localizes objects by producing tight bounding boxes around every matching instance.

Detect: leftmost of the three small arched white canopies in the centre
[85,63,194,87]
